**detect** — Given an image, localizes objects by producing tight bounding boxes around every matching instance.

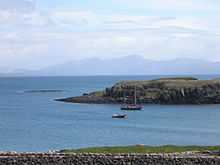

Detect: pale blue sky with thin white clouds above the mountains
[0,0,220,72]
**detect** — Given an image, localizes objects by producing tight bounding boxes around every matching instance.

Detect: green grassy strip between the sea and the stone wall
[61,145,220,154]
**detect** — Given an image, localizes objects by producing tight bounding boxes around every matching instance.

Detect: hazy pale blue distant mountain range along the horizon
[1,55,220,76]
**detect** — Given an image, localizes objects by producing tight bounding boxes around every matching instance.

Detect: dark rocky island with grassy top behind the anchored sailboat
[57,77,220,104]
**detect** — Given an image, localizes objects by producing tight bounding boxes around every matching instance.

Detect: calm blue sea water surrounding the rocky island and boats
[0,75,220,151]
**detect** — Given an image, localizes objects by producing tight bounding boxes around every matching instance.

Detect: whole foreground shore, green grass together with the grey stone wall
[0,145,220,165]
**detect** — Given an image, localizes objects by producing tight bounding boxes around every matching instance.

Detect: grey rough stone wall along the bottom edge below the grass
[0,153,220,165]
